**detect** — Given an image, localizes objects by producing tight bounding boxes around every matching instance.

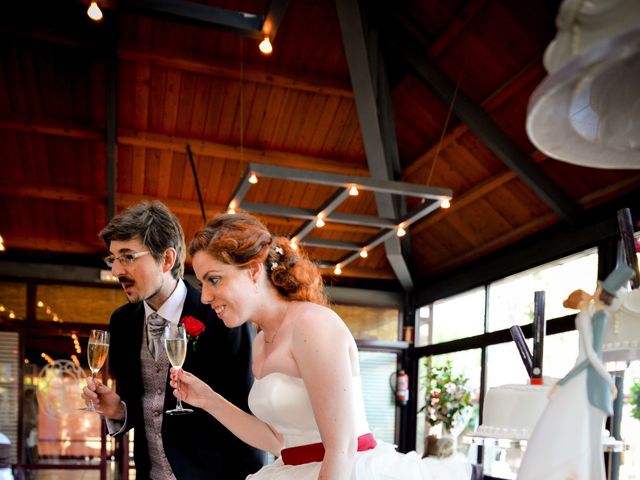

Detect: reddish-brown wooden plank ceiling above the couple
[0,0,640,292]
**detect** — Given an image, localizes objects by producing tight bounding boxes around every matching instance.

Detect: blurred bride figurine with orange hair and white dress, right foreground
[518,265,634,480]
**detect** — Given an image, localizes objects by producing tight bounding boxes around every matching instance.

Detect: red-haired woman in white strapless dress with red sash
[171,213,460,480]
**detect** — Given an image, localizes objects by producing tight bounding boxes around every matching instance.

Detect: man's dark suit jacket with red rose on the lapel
[109,281,265,480]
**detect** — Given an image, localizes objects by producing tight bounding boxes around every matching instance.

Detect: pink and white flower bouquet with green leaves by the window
[421,359,471,431]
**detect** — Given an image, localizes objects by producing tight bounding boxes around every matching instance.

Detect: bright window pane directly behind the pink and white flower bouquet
[416,348,482,461]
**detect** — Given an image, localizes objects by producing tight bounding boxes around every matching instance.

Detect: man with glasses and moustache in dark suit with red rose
[83,201,264,480]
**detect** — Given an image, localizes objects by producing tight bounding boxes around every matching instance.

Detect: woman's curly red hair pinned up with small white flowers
[189,213,327,305]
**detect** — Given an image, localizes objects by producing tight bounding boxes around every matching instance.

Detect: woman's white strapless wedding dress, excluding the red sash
[247,372,471,480]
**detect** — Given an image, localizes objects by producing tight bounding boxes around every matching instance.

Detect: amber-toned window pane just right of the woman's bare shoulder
[331,305,400,341]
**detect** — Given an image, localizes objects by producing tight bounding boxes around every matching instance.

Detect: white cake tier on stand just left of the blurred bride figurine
[475,384,551,440]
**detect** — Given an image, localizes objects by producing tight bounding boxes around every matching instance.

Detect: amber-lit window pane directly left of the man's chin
[36,285,127,324]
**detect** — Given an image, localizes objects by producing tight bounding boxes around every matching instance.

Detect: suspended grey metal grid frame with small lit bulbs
[227,163,452,268]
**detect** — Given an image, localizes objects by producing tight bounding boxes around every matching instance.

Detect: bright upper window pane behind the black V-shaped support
[488,249,598,331]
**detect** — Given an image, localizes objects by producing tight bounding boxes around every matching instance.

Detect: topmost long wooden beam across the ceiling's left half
[118,44,353,98]
